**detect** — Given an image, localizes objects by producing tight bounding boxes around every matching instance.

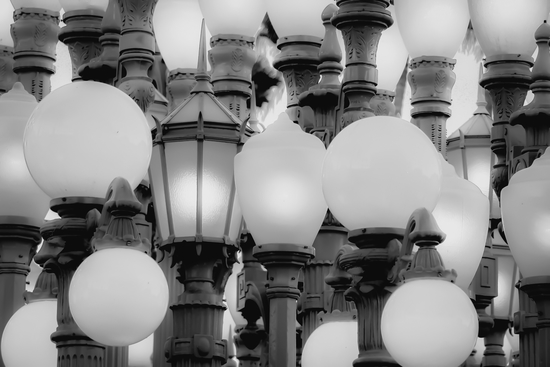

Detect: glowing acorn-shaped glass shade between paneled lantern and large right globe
[235,113,327,246]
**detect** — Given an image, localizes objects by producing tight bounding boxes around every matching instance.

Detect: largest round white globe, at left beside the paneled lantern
[24,81,152,199]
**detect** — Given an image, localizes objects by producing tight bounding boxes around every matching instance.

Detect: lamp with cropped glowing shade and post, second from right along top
[395,0,469,156]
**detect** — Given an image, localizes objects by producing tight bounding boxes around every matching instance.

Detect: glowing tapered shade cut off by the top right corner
[468,0,548,57]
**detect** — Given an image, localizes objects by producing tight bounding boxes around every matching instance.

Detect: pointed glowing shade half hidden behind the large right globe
[433,160,489,292]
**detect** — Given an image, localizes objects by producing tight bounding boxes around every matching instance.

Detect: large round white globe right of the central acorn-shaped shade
[323,116,441,230]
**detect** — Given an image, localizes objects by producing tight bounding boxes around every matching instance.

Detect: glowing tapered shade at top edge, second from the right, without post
[395,0,470,59]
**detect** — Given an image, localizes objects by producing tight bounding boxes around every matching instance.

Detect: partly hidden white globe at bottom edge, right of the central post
[302,320,359,367]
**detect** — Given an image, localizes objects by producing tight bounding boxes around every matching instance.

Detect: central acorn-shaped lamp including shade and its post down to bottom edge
[235,113,327,367]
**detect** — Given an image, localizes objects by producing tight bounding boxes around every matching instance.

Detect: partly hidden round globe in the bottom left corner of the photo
[1,299,57,367]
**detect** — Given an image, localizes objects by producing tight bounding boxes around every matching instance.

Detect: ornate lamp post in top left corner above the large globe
[11,0,61,101]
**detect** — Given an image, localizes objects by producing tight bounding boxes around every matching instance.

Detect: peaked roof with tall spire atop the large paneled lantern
[154,21,252,143]
